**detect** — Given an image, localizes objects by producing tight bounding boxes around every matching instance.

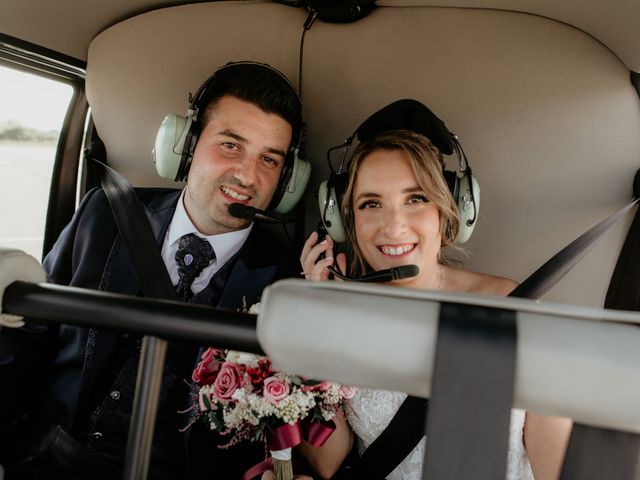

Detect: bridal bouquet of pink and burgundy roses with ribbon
[192,348,355,480]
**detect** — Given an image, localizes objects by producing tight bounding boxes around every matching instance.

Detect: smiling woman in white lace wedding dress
[300,102,571,480]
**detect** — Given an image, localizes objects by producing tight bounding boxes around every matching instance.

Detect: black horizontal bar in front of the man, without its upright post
[2,282,264,354]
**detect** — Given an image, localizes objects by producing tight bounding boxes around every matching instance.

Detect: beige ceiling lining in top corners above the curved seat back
[5,0,640,72]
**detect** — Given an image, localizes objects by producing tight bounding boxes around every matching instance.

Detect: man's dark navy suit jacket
[0,189,297,478]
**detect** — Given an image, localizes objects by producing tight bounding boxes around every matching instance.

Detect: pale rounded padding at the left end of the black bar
[0,247,47,328]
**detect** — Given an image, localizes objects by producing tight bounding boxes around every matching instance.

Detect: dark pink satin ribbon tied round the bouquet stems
[242,421,336,480]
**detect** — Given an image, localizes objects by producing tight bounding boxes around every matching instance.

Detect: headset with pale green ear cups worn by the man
[153,62,311,214]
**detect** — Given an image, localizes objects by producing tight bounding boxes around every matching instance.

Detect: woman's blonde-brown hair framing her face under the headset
[342,130,460,275]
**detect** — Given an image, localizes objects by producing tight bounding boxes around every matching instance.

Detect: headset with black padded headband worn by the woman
[318,100,480,244]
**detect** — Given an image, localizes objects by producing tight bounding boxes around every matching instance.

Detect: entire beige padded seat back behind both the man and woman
[87,2,640,306]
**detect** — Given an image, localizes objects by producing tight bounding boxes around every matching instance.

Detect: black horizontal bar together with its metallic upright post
[2,282,264,480]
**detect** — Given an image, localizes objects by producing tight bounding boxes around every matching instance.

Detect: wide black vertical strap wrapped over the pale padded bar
[423,303,517,480]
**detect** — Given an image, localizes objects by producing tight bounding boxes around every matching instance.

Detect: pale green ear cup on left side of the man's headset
[153,113,191,180]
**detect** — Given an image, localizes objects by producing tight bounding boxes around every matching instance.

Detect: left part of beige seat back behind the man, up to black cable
[87,2,305,185]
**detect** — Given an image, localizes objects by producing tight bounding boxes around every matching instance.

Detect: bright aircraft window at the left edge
[0,66,73,259]
